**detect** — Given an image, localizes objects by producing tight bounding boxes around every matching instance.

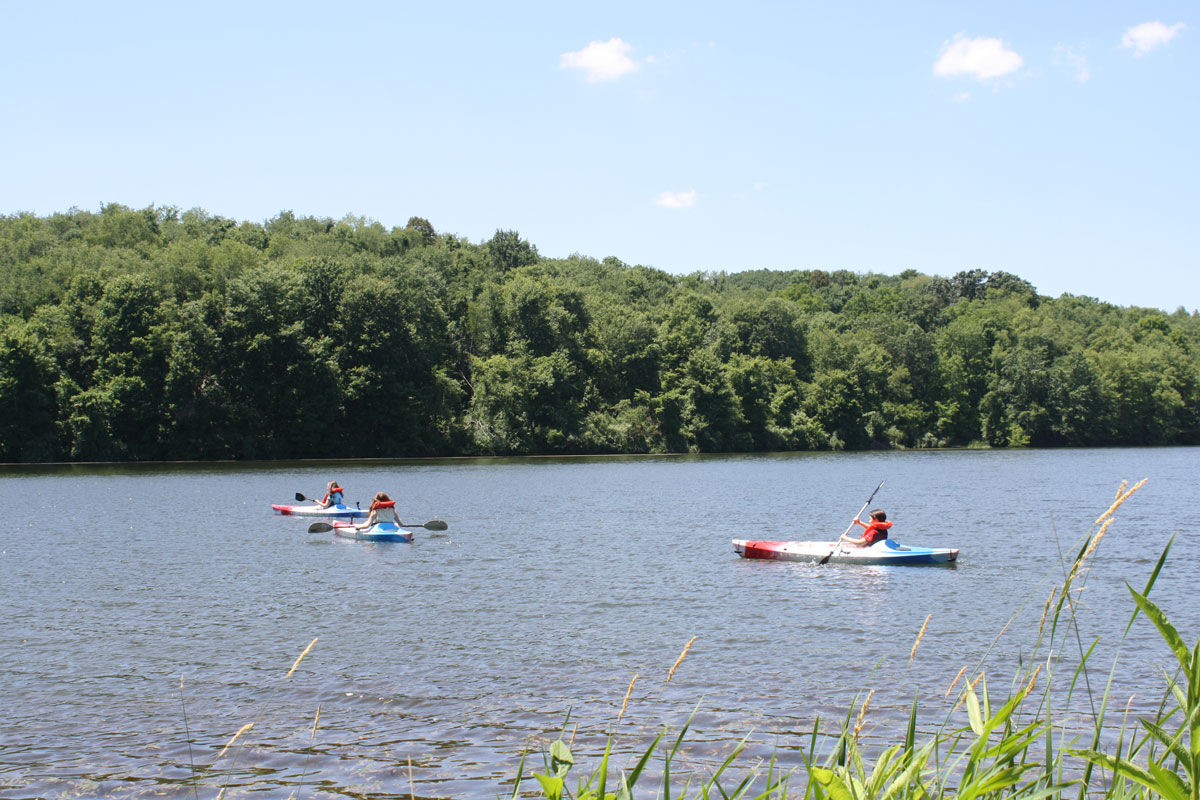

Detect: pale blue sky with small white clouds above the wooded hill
[0,0,1200,311]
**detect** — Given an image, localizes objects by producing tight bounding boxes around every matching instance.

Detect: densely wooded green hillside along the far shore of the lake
[0,205,1200,462]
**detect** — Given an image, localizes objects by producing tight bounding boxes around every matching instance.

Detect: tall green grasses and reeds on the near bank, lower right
[511,481,1200,800]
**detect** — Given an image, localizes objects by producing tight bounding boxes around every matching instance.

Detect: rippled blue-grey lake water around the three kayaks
[0,449,1200,798]
